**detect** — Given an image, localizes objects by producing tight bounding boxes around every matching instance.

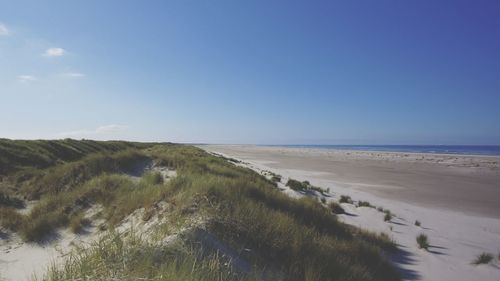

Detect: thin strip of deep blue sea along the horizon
[273,145,500,156]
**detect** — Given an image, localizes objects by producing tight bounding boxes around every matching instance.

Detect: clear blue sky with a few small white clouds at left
[0,0,500,144]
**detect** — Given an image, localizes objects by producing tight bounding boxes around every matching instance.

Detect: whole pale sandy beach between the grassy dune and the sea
[201,145,500,281]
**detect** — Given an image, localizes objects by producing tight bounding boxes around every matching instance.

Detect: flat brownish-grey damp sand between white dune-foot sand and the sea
[199,145,500,218]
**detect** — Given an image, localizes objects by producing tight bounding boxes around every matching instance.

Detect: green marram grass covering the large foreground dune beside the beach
[0,139,400,281]
